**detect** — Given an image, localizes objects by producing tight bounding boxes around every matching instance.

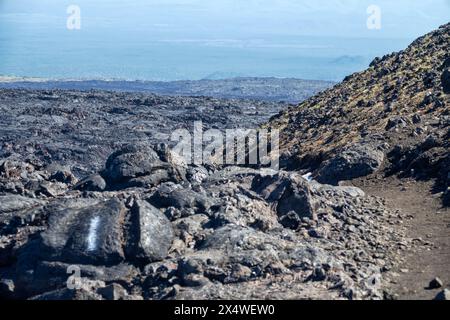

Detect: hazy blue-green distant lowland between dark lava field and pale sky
[0,31,414,81]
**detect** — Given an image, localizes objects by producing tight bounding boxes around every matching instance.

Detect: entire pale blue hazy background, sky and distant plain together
[0,0,450,81]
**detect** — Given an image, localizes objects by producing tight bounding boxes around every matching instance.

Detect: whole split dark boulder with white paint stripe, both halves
[19,198,174,270]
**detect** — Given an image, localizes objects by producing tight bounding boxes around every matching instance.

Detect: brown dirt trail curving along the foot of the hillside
[354,179,450,300]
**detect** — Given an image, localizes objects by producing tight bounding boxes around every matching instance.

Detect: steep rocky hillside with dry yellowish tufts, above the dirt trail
[267,24,450,204]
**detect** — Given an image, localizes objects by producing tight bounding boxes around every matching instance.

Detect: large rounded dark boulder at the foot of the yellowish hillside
[316,145,384,185]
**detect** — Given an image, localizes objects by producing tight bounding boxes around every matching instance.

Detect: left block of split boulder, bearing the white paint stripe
[40,198,126,265]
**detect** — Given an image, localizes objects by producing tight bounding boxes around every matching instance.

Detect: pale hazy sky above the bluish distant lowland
[0,0,450,40]
